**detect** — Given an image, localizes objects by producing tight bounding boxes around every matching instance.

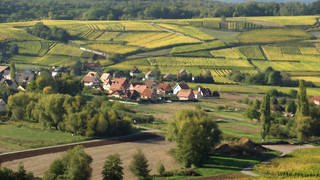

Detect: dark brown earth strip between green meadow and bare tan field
[0,131,163,164]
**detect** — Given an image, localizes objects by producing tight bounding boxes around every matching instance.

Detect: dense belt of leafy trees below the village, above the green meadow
[8,93,132,136]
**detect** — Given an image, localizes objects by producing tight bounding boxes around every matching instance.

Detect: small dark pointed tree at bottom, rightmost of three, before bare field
[130,149,150,179]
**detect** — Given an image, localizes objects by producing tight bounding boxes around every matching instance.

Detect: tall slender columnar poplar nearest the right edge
[296,80,312,142]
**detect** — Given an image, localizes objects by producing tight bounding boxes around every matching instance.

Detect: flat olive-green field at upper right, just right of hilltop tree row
[239,29,312,44]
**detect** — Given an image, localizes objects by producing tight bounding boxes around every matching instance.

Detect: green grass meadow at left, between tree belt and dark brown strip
[0,123,87,151]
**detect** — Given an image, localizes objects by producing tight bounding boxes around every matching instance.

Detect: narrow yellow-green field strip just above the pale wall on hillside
[87,43,139,54]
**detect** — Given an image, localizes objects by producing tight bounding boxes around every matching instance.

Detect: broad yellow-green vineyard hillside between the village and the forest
[0,16,320,84]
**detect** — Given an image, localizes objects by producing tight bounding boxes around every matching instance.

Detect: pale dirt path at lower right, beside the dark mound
[241,144,314,177]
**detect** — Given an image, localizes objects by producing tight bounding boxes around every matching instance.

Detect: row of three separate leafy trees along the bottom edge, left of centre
[43,146,150,180]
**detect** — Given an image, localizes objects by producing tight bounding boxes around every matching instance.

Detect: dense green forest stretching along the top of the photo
[0,0,320,22]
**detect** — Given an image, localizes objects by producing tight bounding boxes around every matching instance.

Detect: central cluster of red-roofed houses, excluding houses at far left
[82,70,218,101]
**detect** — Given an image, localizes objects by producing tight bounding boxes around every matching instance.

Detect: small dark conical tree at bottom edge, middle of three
[102,154,123,180]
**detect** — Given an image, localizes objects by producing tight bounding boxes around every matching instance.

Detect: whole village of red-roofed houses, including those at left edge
[0,63,220,104]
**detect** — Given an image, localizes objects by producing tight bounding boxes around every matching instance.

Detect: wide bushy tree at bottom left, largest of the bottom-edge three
[43,146,92,180]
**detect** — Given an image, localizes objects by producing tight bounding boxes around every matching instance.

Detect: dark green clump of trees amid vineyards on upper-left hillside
[27,22,71,42]
